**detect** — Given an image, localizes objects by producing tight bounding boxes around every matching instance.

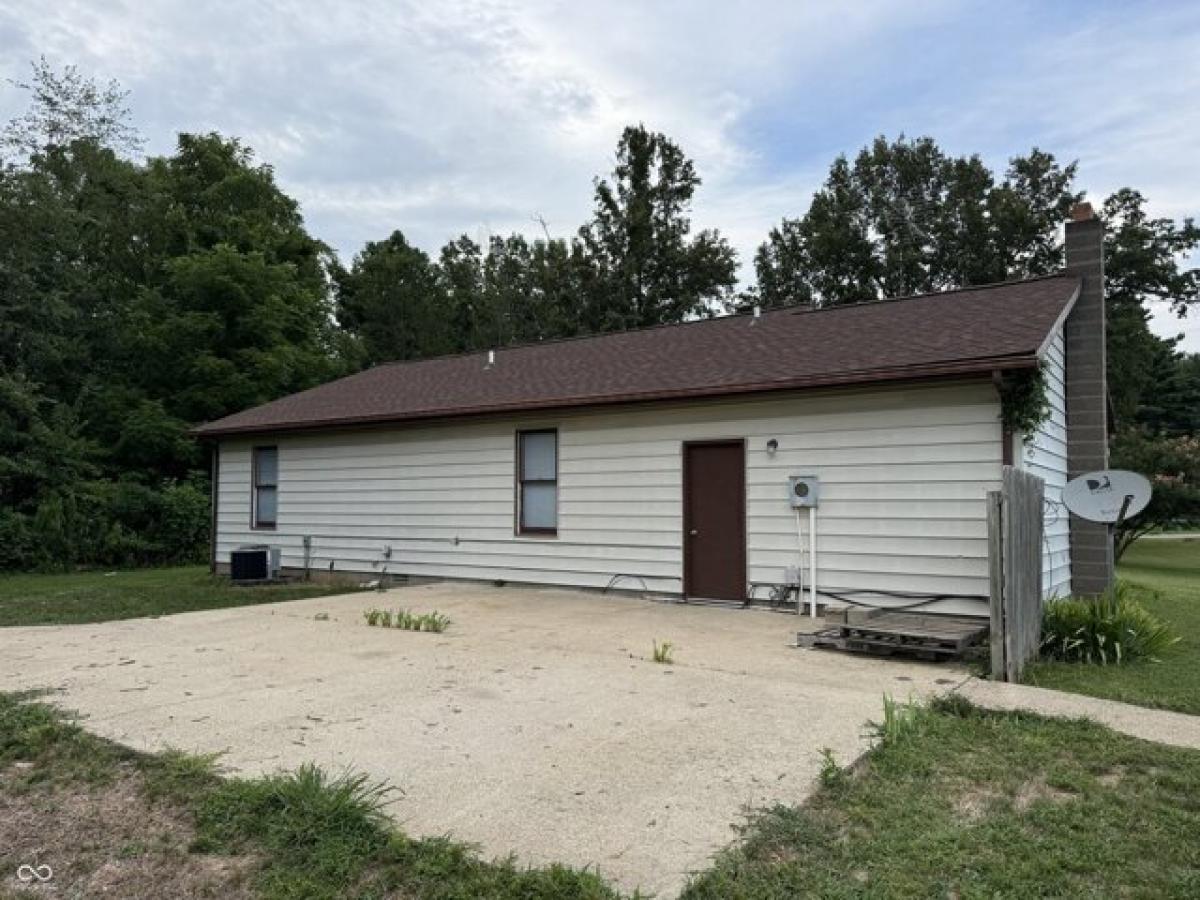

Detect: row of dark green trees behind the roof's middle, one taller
[334,126,737,365]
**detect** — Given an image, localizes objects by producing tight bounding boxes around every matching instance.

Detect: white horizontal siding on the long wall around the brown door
[217,383,1001,611]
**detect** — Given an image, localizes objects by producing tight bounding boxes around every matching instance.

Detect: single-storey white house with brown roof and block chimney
[197,208,1111,614]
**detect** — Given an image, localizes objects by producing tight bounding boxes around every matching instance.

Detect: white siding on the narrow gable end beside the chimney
[1020,330,1070,598]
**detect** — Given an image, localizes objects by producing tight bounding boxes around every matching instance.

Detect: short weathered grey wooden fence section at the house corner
[988,466,1045,682]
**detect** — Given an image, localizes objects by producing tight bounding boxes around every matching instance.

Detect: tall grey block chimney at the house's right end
[1064,203,1112,594]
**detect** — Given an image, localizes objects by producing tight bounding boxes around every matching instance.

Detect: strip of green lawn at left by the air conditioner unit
[0,565,355,625]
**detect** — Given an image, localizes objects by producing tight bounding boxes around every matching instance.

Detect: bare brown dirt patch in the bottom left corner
[0,767,254,900]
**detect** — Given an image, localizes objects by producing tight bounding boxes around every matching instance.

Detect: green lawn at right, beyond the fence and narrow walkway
[1026,538,1200,715]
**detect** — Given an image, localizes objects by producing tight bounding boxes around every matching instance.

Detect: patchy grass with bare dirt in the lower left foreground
[0,694,617,900]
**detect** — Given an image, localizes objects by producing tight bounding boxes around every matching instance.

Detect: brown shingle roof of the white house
[194,275,1079,437]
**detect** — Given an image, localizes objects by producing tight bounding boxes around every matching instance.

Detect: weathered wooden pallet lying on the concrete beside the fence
[797,610,988,659]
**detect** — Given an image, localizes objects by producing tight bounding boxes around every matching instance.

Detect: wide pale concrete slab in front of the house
[0,584,965,895]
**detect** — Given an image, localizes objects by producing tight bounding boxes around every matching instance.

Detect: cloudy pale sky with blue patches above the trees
[0,0,1200,350]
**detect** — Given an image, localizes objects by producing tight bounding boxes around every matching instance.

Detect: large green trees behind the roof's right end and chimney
[744,136,1200,433]
